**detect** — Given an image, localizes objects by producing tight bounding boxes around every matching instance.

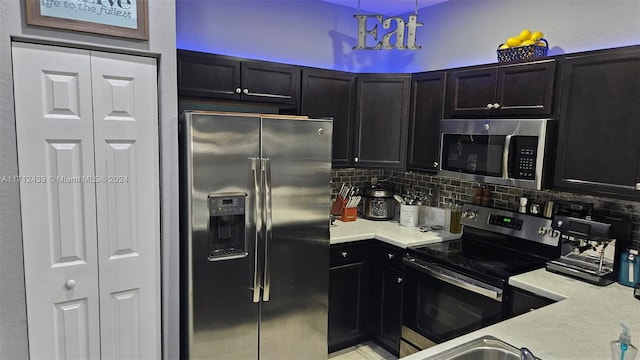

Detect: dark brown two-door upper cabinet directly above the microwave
[445,59,556,118]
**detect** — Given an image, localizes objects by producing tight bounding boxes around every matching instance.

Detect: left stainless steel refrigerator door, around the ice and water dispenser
[181,113,261,359]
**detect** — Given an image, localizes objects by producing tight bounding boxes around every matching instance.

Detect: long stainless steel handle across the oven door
[404,258,502,302]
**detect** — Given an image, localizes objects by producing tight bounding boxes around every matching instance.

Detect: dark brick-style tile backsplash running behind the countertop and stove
[331,168,640,248]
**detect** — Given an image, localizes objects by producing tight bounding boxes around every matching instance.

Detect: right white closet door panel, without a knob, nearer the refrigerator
[91,52,161,358]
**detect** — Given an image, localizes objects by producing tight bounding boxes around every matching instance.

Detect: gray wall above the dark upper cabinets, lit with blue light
[176,0,640,73]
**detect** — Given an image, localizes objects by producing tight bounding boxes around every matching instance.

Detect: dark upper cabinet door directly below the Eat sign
[354,74,411,169]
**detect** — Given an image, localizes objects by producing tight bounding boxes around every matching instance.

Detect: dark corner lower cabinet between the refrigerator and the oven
[329,240,403,356]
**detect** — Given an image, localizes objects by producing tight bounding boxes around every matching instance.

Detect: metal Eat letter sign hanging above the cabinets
[353,15,424,50]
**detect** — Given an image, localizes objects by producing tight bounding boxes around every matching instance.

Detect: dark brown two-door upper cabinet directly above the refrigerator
[178,50,300,106]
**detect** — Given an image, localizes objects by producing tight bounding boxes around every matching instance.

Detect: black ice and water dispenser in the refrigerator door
[207,193,248,261]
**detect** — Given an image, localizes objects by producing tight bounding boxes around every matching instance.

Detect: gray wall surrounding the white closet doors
[0,0,179,359]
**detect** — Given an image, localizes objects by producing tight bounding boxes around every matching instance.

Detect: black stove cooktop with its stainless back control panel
[407,204,559,284]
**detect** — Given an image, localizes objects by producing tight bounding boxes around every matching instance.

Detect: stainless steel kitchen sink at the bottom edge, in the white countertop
[425,335,536,360]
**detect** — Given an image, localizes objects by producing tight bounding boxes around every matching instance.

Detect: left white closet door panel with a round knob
[12,43,100,359]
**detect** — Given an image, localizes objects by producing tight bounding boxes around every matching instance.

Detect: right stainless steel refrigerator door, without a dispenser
[260,118,332,360]
